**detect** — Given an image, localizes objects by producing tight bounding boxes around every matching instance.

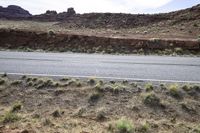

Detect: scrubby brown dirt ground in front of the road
[0,75,200,133]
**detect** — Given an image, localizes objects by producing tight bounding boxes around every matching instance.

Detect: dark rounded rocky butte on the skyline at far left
[0,5,32,19]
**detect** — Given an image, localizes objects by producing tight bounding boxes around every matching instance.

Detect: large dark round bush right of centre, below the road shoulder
[143,93,161,106]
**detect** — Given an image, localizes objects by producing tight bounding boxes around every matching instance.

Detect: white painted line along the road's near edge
[0,72,200,84]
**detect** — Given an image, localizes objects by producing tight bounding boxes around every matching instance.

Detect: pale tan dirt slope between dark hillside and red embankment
[0,20,200,40]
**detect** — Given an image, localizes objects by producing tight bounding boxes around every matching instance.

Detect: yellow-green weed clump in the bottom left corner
[0,111,20,123]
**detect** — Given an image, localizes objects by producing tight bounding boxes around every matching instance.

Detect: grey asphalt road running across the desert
[0,51,200,83]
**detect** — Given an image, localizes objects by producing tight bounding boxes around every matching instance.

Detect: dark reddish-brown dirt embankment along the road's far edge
[0,29,200,54]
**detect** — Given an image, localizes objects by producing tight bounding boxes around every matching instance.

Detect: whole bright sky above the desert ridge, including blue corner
[0,0,200,14]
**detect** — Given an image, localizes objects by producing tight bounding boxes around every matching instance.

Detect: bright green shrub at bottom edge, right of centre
[116,118,134,133]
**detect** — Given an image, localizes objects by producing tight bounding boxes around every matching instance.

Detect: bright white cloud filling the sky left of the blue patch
[0,0,172,14]
